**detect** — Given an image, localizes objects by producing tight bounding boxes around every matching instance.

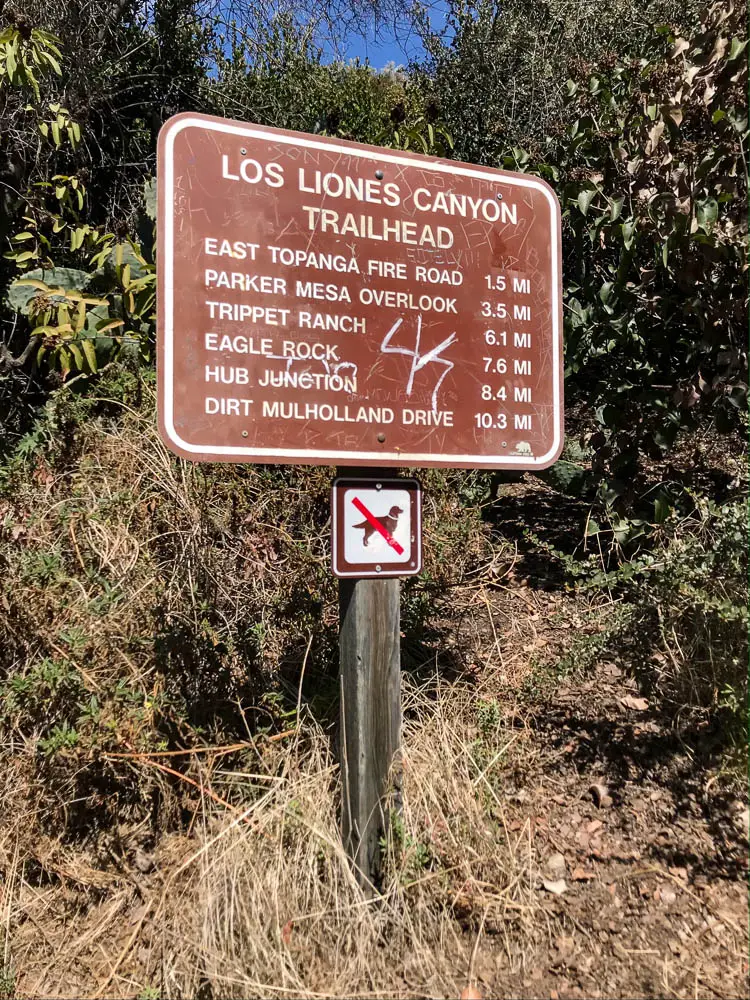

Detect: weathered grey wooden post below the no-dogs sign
[339,579,401,892]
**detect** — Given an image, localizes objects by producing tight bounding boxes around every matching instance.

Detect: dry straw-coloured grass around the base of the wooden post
[0,683,560,997]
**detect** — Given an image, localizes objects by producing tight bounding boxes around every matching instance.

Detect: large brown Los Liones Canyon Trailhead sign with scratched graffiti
[158,114,563,469]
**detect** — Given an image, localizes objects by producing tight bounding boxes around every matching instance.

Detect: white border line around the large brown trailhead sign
[159,114,562,468]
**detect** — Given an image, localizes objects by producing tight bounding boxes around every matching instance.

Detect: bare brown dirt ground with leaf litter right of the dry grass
[468,664,748,1000]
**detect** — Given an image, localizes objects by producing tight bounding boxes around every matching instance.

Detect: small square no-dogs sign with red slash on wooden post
[331,476,422,579]
